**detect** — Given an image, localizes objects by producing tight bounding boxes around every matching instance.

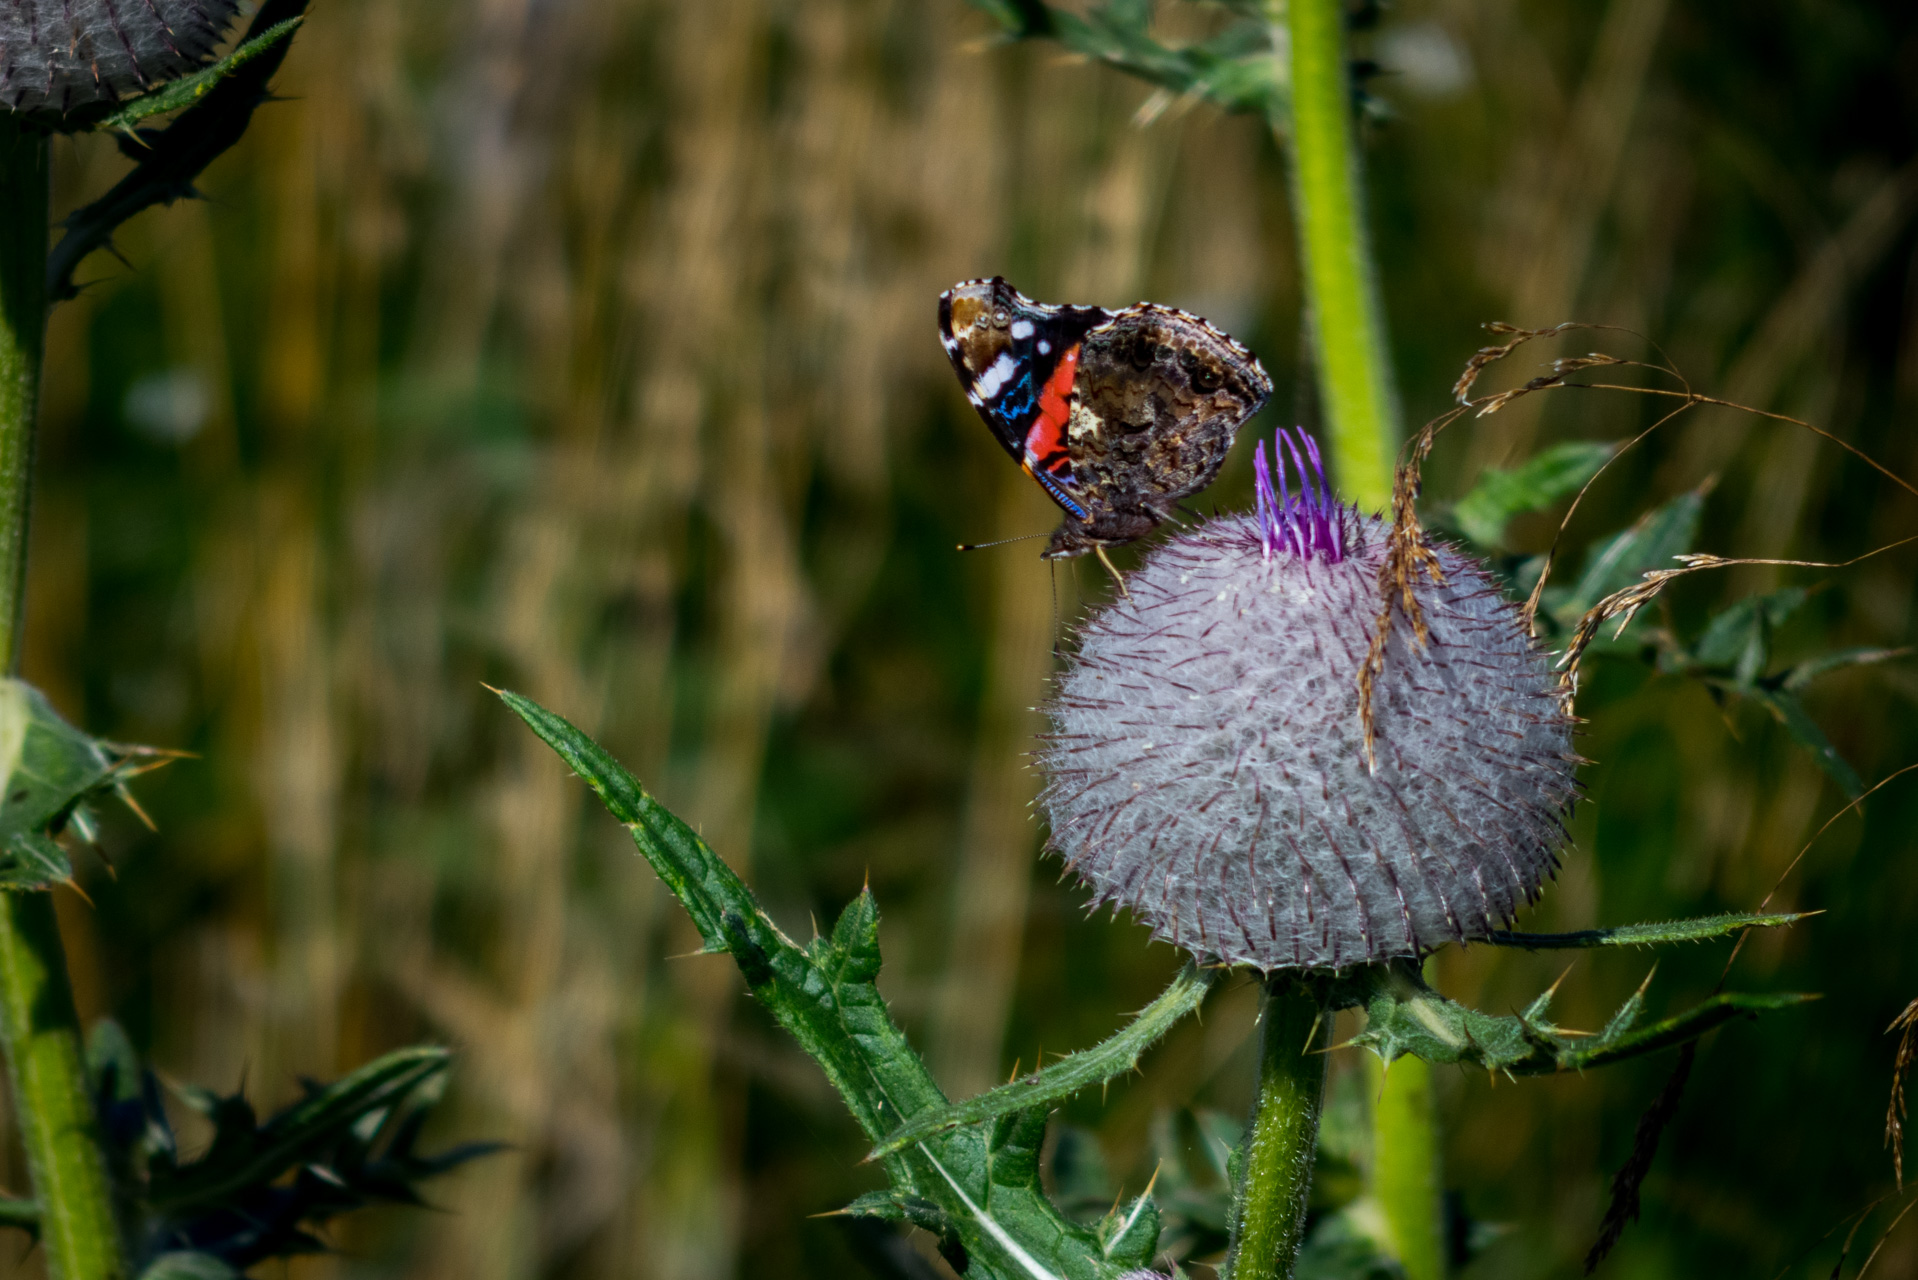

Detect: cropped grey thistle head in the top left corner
[0,0,238,115]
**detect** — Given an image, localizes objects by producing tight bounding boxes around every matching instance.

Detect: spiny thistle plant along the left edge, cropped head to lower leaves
[0,0,491,1280]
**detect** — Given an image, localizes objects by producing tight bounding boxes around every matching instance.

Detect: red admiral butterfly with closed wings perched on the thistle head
[940,276,1272,560]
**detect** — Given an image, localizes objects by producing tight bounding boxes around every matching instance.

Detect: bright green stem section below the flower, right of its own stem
[1366,1054,1446,1280]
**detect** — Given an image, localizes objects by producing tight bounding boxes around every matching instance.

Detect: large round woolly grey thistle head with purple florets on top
[1038,432,1577,969]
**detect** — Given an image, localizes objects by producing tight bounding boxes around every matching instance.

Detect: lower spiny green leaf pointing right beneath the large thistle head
[1345,961,1813,1077]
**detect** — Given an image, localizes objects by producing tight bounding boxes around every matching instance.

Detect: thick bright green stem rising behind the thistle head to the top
[1266,0,1398,510]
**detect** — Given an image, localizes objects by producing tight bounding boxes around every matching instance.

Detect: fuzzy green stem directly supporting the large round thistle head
[1222,973,1325,1280]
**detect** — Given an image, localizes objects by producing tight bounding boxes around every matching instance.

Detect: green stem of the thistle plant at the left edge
[0,111,127,1280]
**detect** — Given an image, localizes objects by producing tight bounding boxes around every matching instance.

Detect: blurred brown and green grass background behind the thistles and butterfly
[4,0,1918,1280]
